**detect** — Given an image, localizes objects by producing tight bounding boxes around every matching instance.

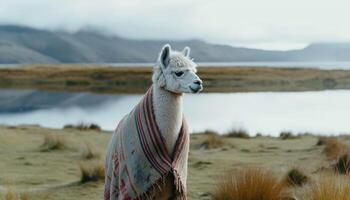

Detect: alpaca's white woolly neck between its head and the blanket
[153,84,183,156]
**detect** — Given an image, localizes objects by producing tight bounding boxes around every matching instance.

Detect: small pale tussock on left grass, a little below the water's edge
[40,133,67,152]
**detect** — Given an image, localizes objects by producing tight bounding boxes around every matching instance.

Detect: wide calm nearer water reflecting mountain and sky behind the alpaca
[0,90,350,135]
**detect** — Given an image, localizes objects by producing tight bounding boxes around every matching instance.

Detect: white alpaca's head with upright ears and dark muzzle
[152,44,203,93]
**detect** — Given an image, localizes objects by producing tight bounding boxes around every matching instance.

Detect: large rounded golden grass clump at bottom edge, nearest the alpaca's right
[213,168,285,200]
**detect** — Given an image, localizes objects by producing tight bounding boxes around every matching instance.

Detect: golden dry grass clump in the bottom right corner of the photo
[300,174,350,200]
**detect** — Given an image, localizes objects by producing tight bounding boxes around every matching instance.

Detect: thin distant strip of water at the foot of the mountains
[0,62,350,69]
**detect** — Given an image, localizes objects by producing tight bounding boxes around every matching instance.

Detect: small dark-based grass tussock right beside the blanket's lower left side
[79,161,105,183]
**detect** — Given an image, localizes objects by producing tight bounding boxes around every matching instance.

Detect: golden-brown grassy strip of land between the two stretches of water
[0,64,350,94]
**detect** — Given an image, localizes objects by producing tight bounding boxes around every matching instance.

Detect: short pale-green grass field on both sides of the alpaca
[0,126,350,200]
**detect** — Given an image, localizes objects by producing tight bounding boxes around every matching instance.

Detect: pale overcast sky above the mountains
[0,0,350,49]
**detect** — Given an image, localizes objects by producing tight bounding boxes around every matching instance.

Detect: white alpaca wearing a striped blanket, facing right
[104,44,203,200]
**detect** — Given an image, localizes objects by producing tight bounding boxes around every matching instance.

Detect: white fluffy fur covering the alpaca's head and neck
[152,45,202,154]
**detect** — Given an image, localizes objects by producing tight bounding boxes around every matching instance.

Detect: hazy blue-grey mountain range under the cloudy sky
[0,25,350,63]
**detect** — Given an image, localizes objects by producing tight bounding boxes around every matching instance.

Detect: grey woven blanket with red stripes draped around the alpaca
[104,87,189,200]
